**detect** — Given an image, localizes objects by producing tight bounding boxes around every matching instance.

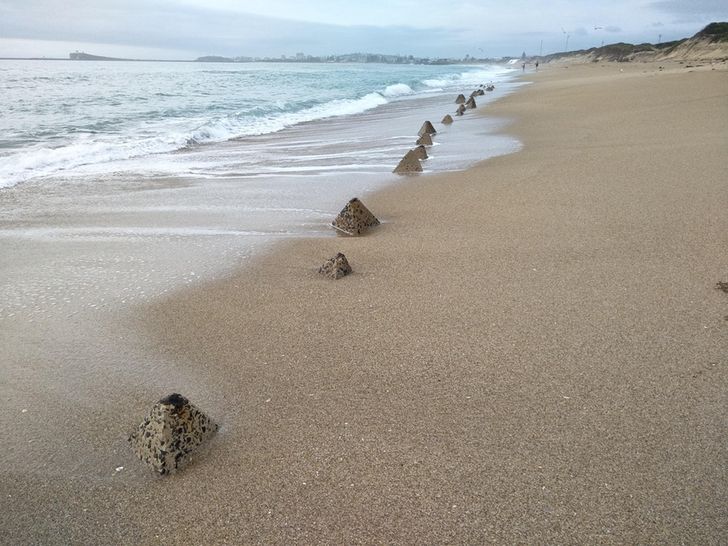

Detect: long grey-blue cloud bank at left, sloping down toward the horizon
[0,0,478,56]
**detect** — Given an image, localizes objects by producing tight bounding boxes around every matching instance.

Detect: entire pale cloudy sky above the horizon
[0,0,728,59]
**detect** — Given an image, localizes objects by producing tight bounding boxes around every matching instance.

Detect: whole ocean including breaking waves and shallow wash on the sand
[0,60,519,318]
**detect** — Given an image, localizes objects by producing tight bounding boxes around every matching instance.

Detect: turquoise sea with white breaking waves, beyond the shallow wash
[0,61,510,187]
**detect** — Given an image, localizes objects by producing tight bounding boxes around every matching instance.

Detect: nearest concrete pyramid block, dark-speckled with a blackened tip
[129,393,218,474]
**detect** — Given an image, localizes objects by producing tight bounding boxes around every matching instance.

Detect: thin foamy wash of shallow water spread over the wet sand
[0,65,518,326]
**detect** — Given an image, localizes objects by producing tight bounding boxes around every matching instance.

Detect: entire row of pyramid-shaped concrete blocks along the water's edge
[129,91,494,475]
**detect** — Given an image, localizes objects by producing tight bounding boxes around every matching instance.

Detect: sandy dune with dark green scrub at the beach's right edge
[542,23,728,62]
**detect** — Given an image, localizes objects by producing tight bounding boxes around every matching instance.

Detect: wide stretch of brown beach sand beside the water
[0,59,728,544]
